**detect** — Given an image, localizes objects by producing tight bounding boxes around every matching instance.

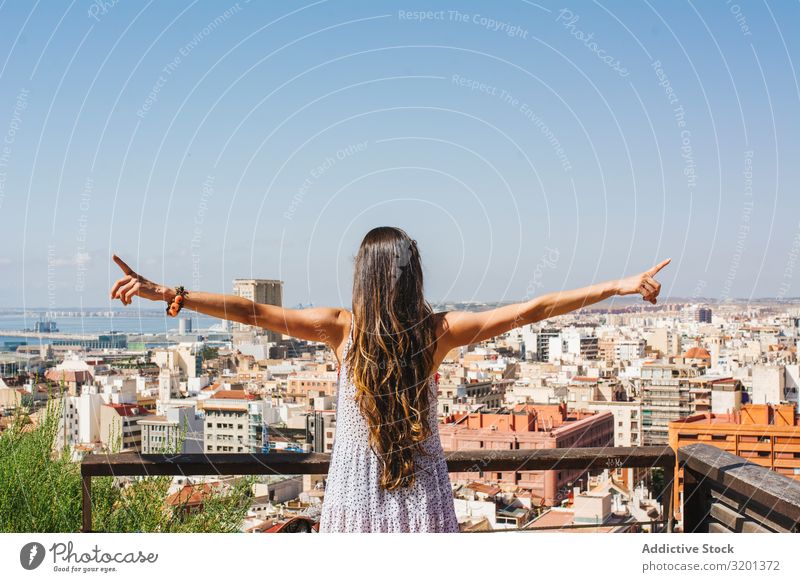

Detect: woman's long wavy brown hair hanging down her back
[345,226,436,491]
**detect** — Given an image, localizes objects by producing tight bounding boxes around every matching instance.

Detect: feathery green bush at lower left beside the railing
[0,386,254,533]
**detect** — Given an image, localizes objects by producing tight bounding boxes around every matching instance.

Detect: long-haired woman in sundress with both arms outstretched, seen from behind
[111,227,669,532]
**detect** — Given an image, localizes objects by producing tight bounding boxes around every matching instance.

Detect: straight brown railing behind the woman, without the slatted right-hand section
[81,446,675,532]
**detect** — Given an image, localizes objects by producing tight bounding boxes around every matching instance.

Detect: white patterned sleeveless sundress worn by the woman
[319,323,459,533]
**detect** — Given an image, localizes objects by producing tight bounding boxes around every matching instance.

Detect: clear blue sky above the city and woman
[0,0,800,309]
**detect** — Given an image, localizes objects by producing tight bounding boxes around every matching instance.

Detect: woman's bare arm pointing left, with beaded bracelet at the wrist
[111,255,345,347]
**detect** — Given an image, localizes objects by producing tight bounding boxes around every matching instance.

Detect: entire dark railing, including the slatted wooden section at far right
[81,444,800,532]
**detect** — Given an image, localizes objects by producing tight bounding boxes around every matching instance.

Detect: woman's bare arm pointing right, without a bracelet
[438,259,671,353]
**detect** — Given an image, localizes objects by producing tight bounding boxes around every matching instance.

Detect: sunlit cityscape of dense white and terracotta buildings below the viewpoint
[0,279,800,533]
